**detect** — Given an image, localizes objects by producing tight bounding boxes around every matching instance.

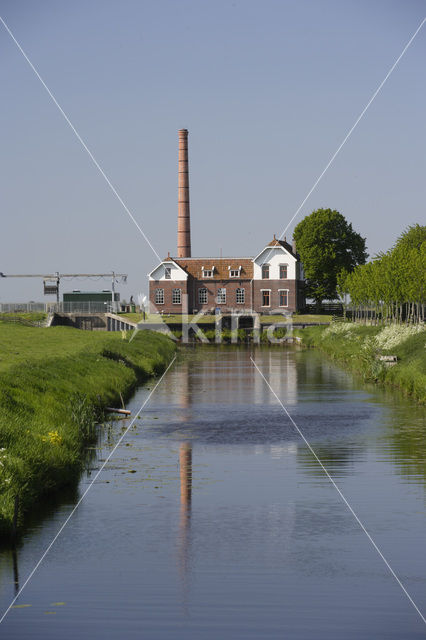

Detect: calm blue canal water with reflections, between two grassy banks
[0,346,426,640]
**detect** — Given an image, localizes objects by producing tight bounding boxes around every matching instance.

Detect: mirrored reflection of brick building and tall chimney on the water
[171,349,297,615]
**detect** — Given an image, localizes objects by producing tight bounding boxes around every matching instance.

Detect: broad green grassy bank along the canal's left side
[0,323,175,540]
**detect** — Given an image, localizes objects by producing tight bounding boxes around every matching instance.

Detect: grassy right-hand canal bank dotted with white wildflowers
[295,323,426,404]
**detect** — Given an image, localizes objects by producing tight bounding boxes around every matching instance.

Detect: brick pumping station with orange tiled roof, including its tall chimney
[149,129,305,314]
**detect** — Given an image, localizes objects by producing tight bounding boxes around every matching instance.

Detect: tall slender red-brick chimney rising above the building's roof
[178,129,191,258]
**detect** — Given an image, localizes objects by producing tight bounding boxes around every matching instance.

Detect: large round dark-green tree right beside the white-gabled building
[293,209,367,305]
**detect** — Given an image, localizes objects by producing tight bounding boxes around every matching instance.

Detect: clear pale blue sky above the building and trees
[0,0,426,302]
